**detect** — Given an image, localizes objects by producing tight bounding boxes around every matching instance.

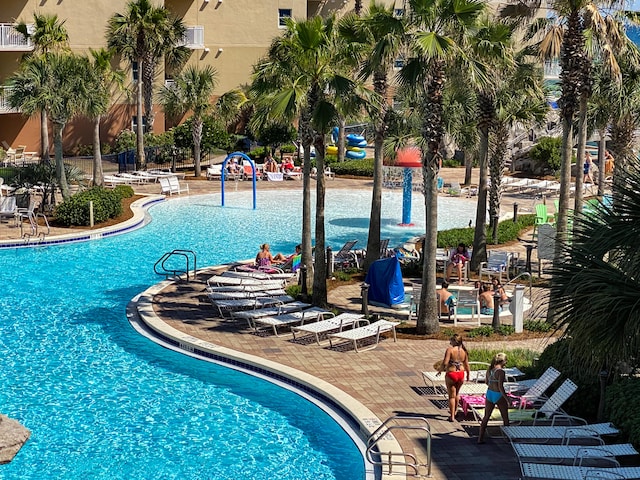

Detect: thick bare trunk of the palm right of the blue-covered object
[416,62,445,335]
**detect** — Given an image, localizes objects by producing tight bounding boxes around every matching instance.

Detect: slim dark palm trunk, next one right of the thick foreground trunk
[469,125,489,271]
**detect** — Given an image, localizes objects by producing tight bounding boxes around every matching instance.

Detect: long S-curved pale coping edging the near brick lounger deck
[127,280,406,480]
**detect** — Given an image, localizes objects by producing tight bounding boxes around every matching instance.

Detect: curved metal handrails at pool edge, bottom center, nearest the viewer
[366,415,431,477]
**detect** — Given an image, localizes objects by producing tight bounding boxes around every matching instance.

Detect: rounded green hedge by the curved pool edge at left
[55,187,124,226]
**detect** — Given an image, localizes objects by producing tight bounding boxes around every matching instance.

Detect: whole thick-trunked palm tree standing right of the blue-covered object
[399,0,486,334]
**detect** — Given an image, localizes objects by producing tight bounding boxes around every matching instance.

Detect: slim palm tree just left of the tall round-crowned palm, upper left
[84,48,124,185]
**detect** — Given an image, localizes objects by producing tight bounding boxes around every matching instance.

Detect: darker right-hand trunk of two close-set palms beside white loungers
[312,136,327,306]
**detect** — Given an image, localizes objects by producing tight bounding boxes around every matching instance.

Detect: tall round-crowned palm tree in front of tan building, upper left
[107,0,185,168]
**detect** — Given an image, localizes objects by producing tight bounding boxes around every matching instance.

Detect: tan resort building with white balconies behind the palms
[0,0,403,152]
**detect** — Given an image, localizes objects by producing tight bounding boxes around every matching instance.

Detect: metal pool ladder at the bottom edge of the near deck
[366,415,431,478]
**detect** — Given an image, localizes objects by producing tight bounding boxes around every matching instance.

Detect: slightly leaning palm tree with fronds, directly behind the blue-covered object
[340,1,404,271]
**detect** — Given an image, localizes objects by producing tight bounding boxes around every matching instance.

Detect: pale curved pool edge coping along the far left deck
[0,194,166,250]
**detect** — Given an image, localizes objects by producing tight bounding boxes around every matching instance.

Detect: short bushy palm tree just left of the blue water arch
[160,65,218,177]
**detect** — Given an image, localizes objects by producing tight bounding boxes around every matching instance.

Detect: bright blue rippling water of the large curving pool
[0,191,474,480]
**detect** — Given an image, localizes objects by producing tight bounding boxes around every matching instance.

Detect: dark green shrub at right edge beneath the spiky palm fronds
[605,378,640,448]
